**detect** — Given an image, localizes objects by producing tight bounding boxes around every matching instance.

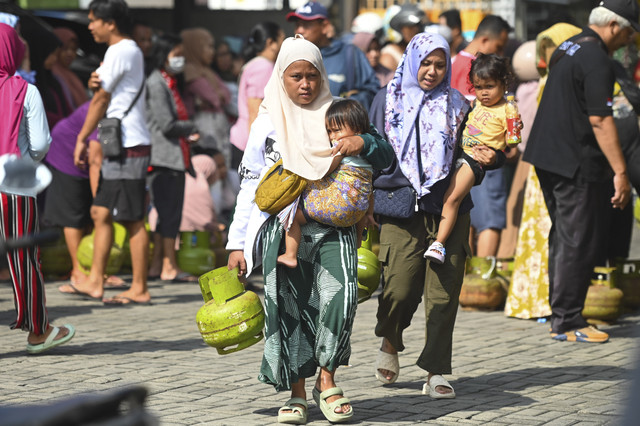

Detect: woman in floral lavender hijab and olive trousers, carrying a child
[371,33,495,398]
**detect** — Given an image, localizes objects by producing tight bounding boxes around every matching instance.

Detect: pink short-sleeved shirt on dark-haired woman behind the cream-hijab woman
[230,56,274,151]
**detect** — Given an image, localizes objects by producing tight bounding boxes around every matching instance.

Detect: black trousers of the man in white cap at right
[536,169,611,333]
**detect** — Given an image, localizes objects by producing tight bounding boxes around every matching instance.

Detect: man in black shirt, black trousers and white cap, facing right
[523,0,640,343]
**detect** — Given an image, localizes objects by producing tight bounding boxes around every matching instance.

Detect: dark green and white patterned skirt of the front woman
[258,216,358,391]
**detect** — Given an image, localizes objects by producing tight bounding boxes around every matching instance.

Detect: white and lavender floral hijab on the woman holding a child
[385,33,469,197]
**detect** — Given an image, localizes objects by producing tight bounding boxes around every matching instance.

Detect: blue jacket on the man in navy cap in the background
[320,39,380,111]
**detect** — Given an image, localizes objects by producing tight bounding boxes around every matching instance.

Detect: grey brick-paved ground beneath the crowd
[0,262,640,425]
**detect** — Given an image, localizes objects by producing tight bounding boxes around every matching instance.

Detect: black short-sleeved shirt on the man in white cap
[523,28,615,181]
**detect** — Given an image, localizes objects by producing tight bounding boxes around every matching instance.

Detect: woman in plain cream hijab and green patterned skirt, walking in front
[227,36,393,424]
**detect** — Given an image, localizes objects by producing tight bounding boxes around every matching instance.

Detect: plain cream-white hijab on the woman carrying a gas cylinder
[260,35,333,180]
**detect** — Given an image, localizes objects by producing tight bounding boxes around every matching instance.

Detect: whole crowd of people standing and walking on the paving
[0,0,640,424]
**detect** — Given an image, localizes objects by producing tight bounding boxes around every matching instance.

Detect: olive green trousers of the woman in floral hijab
[375,212,471,374]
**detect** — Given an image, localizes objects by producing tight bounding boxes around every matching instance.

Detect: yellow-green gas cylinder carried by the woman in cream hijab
[196,266,264,355]
